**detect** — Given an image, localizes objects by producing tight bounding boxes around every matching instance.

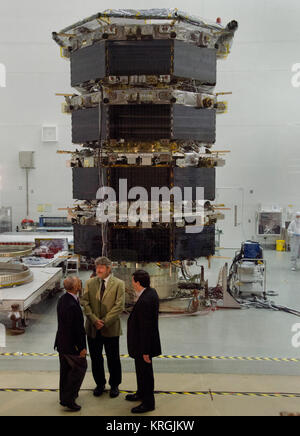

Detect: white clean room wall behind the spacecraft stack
[0,0,300,242]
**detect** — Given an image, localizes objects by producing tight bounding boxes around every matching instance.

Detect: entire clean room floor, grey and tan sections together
[0,250,300,415]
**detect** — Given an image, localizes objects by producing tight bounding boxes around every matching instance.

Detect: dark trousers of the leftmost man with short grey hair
[59,354,87,404]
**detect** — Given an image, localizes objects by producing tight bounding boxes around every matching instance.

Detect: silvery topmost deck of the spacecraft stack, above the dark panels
[53,9,238,57]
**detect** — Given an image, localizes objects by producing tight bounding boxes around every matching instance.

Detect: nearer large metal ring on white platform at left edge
[0,262,33,288]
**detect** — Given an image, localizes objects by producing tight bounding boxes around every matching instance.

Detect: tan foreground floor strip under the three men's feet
[0,372,300,417]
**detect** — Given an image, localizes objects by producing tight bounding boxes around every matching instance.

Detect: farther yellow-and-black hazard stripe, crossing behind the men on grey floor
[0,352,300,363]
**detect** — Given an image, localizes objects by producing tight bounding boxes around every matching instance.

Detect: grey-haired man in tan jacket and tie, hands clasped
[82,257,125,398]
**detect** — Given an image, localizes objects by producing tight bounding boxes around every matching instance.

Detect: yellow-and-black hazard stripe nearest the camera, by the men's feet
[0,388,300,398]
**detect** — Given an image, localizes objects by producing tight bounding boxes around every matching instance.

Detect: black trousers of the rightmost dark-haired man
[135,357,155,408]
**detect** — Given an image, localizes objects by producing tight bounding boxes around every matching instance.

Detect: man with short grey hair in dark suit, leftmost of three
[55,277,87,412]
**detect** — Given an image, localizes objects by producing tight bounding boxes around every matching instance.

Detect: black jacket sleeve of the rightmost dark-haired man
[138,300,156,355]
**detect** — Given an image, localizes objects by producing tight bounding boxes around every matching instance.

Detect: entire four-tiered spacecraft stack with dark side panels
[53,9,238,304]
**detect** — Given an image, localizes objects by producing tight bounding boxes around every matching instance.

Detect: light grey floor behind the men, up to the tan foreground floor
[0,250,300,375]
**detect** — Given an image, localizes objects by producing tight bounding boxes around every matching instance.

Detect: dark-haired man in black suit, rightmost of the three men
[126,270,161,413]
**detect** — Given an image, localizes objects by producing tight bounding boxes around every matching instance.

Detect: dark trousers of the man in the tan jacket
[88,331,122,388]
